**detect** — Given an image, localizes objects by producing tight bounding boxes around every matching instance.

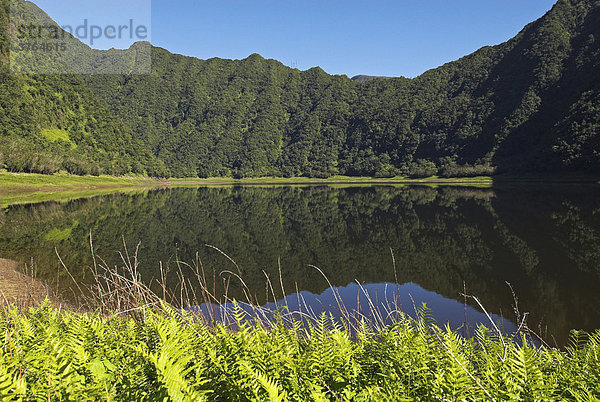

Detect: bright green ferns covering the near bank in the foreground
[0,305,600,401]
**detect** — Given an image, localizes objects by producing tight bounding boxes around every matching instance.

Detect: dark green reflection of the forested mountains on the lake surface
[0,186,600,344]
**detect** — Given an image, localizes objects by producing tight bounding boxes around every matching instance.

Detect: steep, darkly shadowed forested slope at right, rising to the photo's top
[398,0,600,171]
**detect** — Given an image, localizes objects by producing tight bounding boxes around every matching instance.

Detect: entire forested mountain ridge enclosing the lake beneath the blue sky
[0,0,600,177]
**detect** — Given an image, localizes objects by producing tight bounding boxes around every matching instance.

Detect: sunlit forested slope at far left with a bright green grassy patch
[0,0,166,175]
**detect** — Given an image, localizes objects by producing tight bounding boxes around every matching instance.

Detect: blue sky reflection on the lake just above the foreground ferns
[192,282,516,333]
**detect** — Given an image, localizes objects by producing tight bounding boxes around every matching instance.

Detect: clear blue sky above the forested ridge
[34,0,555,77]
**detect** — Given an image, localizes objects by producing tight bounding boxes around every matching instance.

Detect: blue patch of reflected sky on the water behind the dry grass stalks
[192,283,517,336]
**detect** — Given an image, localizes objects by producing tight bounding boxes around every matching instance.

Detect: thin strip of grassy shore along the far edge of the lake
[0,171,600,208]
